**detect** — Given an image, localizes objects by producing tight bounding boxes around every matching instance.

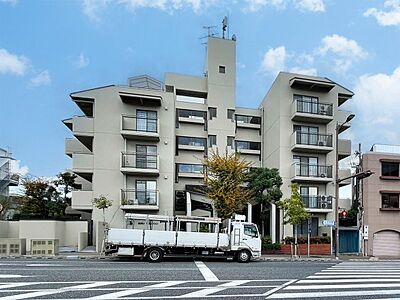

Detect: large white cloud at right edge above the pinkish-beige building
[353,66,400,144]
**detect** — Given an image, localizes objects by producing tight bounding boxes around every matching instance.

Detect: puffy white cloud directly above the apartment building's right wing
[316,34,368,73]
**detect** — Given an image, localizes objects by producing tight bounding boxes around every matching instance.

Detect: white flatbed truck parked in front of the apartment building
[106,213,261,262]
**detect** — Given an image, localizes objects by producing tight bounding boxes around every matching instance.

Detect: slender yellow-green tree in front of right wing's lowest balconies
[277,183,310,255]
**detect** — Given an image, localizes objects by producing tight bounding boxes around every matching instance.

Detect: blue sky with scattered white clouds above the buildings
[0,0,400,176]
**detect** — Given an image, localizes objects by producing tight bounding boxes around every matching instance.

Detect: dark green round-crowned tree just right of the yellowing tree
[248,168,282,236]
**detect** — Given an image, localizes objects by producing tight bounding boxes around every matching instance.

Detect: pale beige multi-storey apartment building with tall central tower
[63,37,353,251]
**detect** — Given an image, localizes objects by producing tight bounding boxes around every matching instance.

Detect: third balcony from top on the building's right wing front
[291,163,333,183]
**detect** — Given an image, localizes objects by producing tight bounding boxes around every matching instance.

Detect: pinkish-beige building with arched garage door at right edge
[362,145,400,256]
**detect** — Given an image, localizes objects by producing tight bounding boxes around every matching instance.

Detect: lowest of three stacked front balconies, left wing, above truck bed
[121,189,160,210]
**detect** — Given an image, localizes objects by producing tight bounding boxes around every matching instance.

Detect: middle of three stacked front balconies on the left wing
[121,152,160,176]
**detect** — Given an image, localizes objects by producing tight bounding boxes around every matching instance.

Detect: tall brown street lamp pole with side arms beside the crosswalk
[335,114,357,258]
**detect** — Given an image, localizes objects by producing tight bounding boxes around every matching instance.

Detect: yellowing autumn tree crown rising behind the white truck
[203,150,252,219]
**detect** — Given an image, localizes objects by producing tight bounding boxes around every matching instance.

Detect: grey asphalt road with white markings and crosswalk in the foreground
[0,259,400,300]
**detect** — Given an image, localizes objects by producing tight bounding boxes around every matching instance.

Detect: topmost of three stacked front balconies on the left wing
[121,116,160,142]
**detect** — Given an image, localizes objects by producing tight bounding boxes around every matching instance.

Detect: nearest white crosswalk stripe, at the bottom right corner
[267,290,400,299]
